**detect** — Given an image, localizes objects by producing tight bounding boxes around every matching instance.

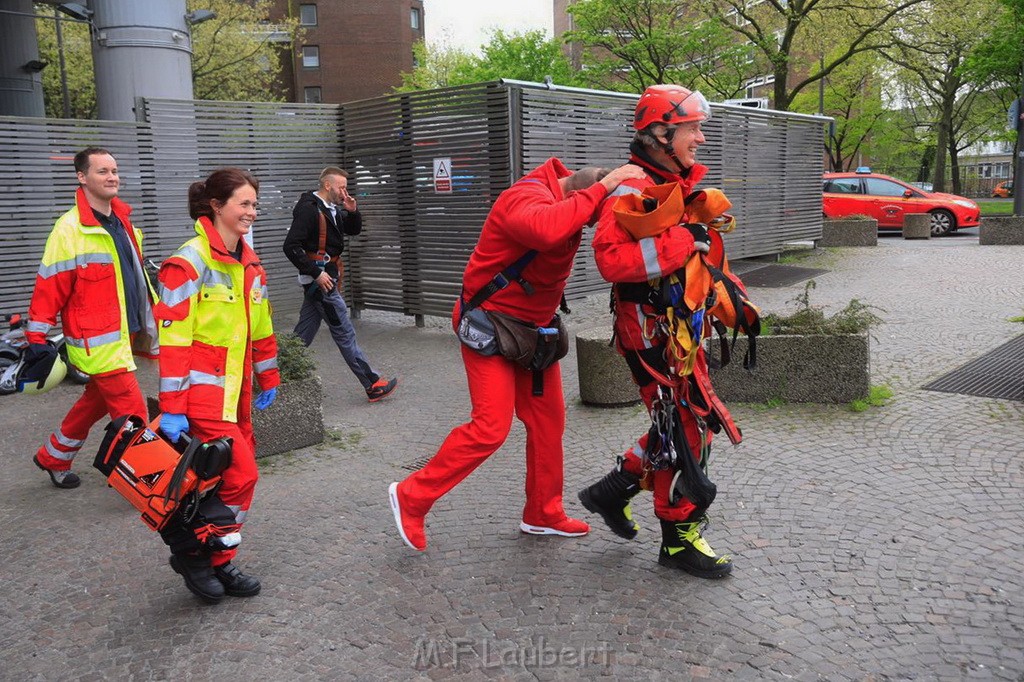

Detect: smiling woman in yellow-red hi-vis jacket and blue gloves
[156,168,281,603]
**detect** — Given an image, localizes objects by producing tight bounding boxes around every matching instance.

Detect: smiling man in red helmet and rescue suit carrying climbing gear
[580,85,732,578]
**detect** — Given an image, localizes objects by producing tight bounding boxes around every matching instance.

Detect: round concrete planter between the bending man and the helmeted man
[575,327,640,408]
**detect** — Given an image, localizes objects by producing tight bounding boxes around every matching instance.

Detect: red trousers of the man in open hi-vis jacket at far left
[36,372,148,471]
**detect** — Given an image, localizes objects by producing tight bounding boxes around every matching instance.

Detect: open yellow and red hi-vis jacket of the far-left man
[26,187,158,374]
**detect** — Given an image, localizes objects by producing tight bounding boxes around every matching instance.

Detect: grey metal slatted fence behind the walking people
[0,81,825,324]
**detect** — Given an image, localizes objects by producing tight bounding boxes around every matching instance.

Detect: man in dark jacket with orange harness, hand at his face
[285,166,398,402]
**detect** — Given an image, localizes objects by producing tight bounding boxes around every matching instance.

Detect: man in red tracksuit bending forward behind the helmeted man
[388,158,643,551]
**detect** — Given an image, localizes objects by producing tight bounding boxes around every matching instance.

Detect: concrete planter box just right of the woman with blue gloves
[253,377,324,458]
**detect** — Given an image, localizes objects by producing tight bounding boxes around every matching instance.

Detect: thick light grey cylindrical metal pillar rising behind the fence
[89,0,193,121]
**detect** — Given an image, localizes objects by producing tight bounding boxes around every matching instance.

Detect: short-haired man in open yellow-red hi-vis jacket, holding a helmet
[26,146,157,487]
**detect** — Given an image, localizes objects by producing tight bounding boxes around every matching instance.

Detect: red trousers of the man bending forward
[398,346,565,526]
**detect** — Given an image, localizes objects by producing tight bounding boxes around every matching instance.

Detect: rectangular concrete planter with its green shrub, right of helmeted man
[711,280,881,402]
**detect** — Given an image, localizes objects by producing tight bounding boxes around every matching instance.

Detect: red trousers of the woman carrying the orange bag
[188,385,259,566]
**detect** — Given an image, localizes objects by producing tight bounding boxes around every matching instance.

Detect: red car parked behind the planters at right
[822,169,981,237]
